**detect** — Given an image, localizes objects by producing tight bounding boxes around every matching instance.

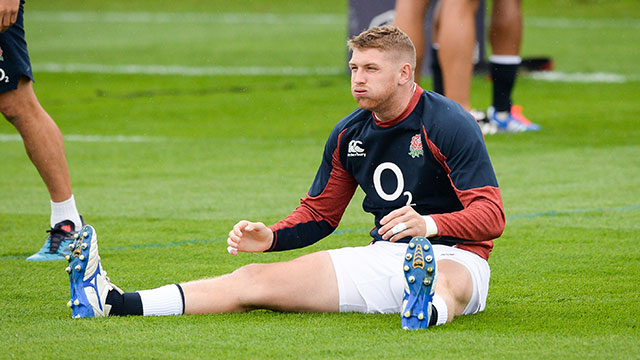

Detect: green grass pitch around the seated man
[0,0,640,359]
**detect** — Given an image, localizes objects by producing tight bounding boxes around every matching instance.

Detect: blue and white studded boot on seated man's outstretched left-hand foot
[65,225,122,318]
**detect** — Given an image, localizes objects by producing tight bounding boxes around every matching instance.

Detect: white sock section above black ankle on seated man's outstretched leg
[138,284,184,316]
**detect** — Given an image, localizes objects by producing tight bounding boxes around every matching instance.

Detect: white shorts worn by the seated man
[328,241,491,314]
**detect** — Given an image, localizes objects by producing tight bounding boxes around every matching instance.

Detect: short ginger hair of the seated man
[347,25,416,69]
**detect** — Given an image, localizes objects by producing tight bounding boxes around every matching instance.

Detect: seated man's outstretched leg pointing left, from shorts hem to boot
[66,226,340,317]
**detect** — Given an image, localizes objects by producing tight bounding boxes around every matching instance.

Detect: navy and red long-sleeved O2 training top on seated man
[268,85,505,259]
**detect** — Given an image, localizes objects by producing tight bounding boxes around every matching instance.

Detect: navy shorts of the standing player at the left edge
[0,0,33,93]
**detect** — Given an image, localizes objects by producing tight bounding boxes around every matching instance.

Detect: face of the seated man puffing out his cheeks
[349,49,401,112]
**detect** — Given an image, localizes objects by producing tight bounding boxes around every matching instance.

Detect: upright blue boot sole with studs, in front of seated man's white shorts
[400,236,436,330]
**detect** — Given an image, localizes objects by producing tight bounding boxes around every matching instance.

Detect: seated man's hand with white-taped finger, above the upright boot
[378,206,427,242]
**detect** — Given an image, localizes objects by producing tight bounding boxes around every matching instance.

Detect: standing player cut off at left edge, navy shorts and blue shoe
[0,0,83,261]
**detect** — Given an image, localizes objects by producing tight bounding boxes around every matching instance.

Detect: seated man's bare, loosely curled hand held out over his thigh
[227,220,273,256]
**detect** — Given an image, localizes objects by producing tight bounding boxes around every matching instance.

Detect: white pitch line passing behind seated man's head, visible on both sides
[33,63,640,83]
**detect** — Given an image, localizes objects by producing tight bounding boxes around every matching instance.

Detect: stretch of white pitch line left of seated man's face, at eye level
[33,63,345,76]
